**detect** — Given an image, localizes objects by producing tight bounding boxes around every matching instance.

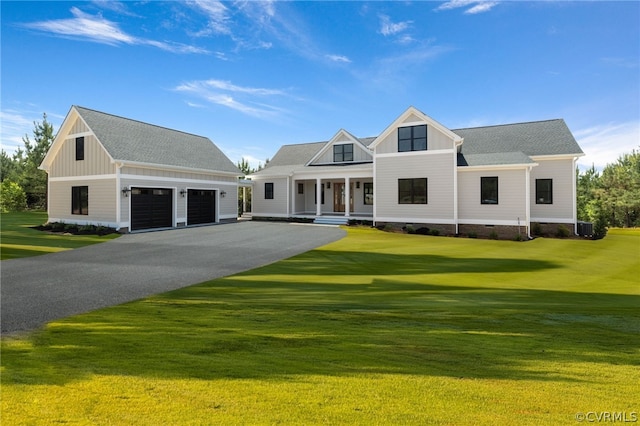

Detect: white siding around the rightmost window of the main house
[530,157,576,223]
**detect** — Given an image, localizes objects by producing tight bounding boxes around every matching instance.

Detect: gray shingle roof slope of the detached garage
[74,106,242,176]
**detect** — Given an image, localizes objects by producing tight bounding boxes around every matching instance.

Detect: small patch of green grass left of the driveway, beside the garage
[0,212,118,260]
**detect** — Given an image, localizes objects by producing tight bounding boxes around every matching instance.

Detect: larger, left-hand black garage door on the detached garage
[131,188,173,231]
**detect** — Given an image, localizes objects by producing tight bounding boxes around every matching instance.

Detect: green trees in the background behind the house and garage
[0,114,640,237]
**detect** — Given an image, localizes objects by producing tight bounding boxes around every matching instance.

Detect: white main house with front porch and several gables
[250,107,584,237]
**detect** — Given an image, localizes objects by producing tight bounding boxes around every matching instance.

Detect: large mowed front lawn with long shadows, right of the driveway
[1,228,640,425]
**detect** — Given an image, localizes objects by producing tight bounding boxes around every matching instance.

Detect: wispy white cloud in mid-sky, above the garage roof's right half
[175,79,286,119]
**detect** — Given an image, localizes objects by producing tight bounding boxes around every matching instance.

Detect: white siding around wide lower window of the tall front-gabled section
[374,149,456,223]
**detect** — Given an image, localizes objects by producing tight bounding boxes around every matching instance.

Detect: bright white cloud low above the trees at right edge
[573,121,640,170]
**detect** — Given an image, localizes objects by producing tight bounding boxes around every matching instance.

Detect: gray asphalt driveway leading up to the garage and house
[0,222,345,334]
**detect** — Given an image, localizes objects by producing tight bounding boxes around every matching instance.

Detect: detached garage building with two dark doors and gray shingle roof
[40,106,242,232]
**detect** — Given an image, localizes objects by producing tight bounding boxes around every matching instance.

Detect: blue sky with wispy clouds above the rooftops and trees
[0,0,640,168]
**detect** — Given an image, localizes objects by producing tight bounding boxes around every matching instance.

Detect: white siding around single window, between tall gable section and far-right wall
[458,169,528,226]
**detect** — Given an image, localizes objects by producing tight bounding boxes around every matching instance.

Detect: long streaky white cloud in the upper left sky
[23,7,208,53]
